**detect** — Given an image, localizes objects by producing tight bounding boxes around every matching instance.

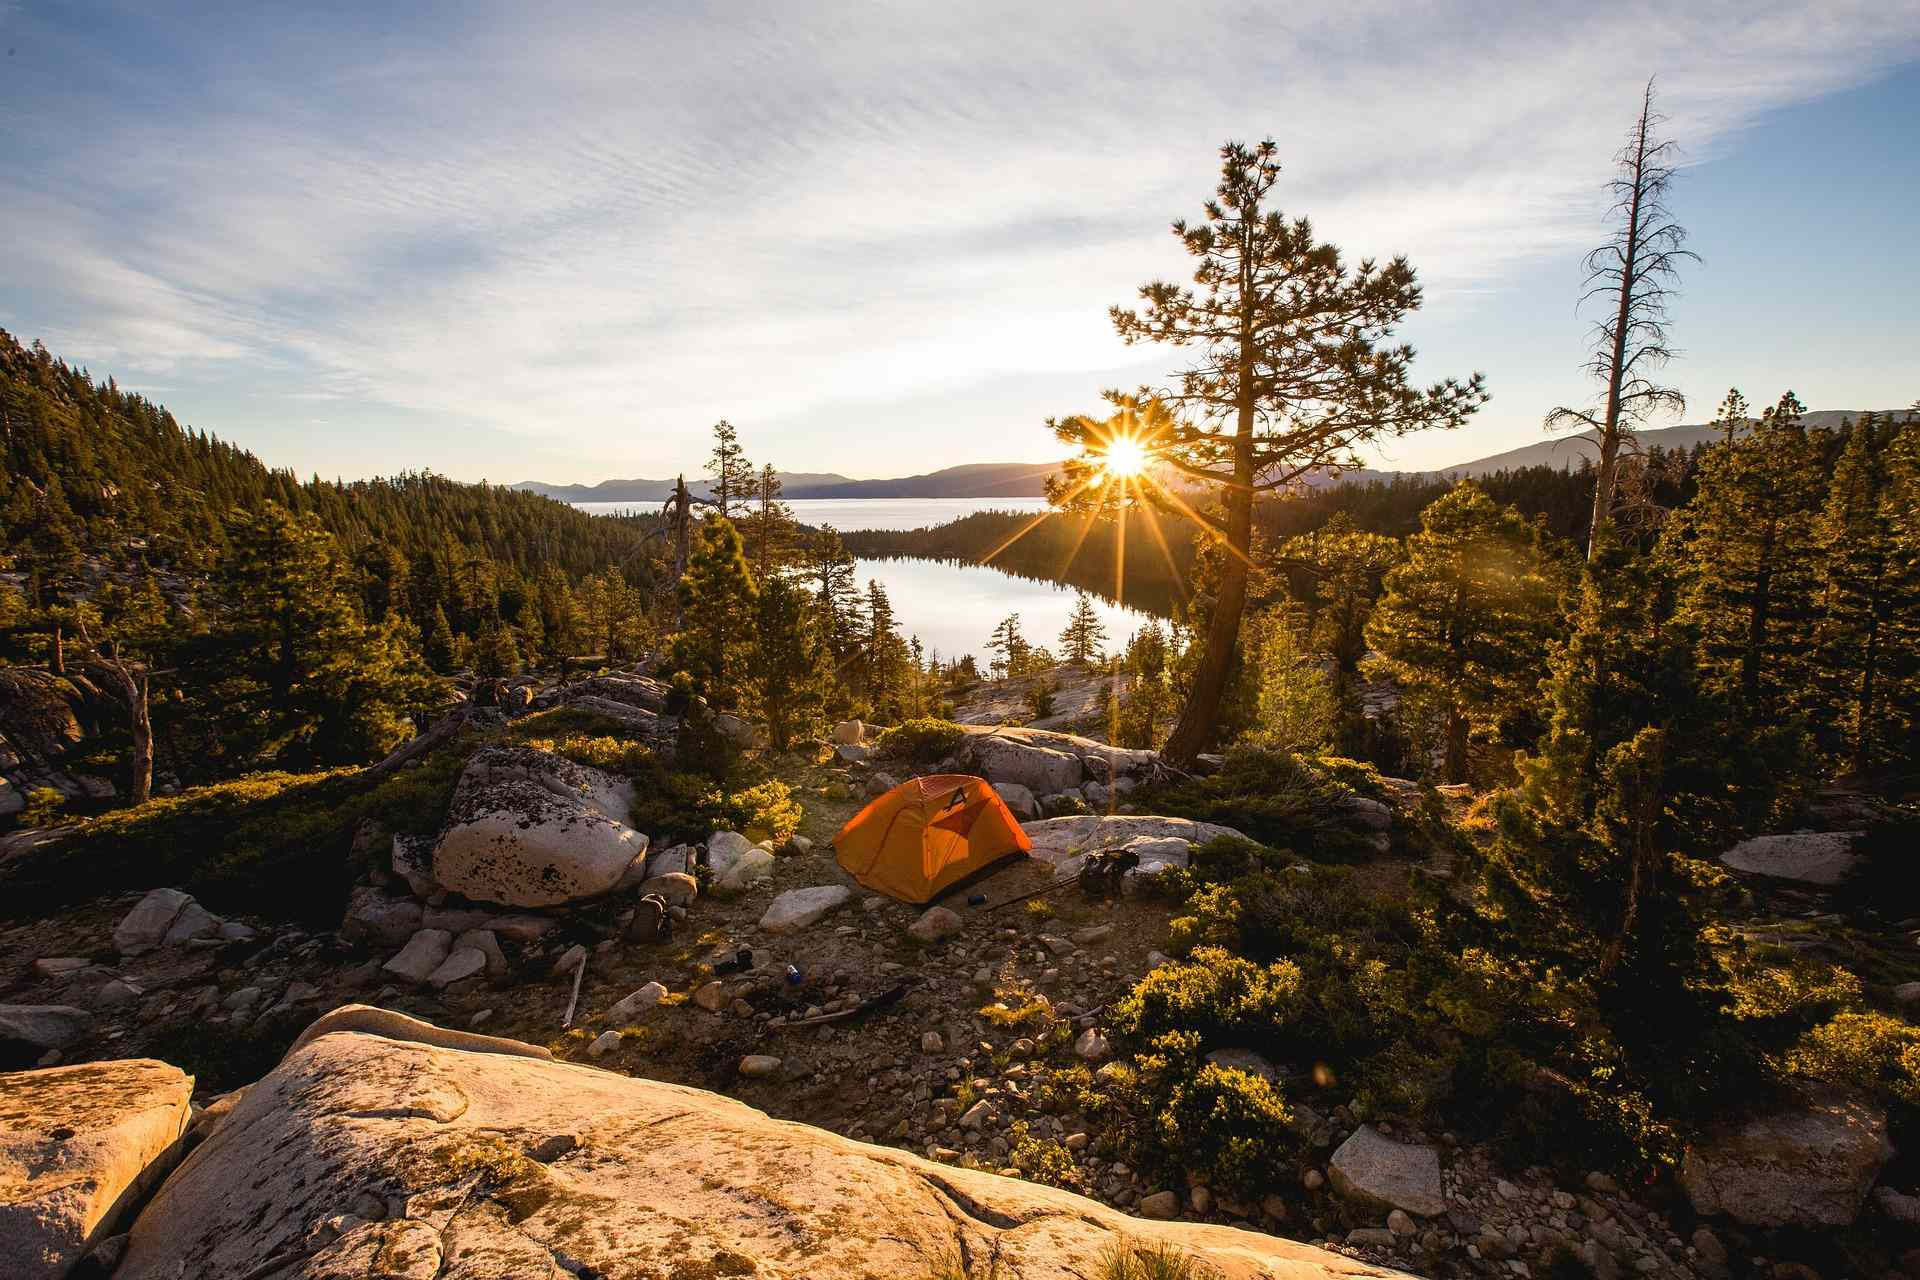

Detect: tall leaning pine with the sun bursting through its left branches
[1052,138,1486,764]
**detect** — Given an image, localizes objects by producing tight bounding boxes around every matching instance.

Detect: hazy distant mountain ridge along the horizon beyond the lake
[513,409,1905,503]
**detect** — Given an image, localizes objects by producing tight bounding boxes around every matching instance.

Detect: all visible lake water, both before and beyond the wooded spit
[574,497,1148,666]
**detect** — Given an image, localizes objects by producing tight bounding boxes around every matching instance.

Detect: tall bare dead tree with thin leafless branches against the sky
[1546,81,1699,558]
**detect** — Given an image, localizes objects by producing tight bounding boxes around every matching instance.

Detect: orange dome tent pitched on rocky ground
[833,773,1033,904]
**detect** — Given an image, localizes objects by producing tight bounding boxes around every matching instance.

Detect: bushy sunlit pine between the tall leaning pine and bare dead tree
[1367,482,1557,783]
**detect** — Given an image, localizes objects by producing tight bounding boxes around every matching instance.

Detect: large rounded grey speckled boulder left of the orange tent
[434,747,647,906]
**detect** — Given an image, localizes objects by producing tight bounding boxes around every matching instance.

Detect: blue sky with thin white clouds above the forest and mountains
[0,0,1920,480]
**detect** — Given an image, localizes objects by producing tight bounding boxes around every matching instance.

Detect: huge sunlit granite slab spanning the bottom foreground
[115,1011,1396,1280]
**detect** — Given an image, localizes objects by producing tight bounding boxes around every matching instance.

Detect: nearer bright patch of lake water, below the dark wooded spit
[856,560,1150,672]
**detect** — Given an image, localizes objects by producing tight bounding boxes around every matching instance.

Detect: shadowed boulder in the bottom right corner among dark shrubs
[1680,1088,1893,1226]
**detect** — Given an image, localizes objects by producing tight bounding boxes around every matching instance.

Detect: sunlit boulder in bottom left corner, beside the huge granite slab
[0,1057,194,1280]
